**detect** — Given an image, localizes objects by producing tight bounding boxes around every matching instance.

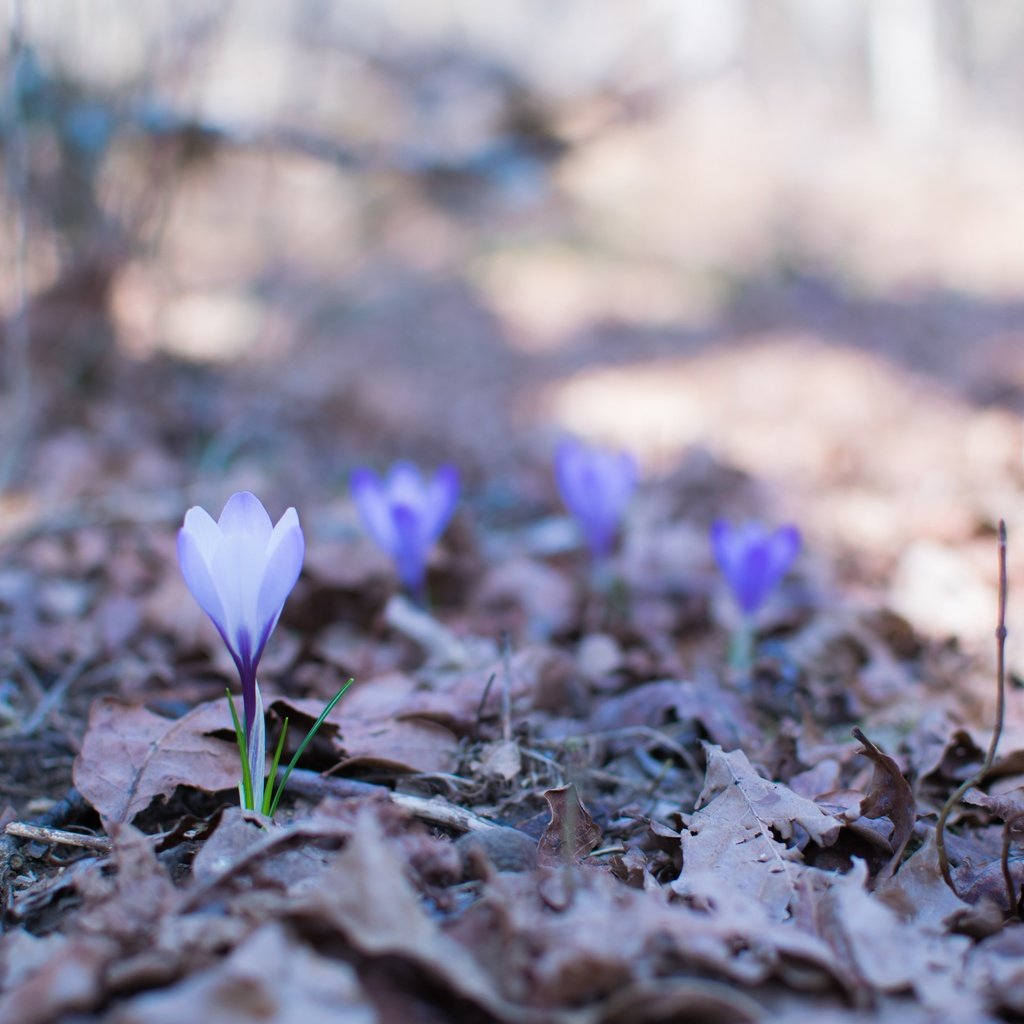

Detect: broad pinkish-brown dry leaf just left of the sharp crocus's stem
[73,697,239,821]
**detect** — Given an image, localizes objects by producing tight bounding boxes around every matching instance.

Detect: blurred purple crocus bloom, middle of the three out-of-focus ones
[555,438,638,558]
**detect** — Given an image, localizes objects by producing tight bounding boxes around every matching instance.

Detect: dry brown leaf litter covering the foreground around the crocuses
[0,385,1024,1024]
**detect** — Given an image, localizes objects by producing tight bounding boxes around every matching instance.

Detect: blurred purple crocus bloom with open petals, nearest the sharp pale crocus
[351,462,459,596]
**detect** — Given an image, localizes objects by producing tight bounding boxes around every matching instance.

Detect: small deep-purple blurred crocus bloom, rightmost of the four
[711,519,800,618]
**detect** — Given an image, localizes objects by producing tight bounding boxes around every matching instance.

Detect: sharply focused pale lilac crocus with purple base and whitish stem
[178,492,305,809]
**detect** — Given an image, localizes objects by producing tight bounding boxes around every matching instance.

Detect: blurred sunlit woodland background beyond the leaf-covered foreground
[0,0,1024,659]
